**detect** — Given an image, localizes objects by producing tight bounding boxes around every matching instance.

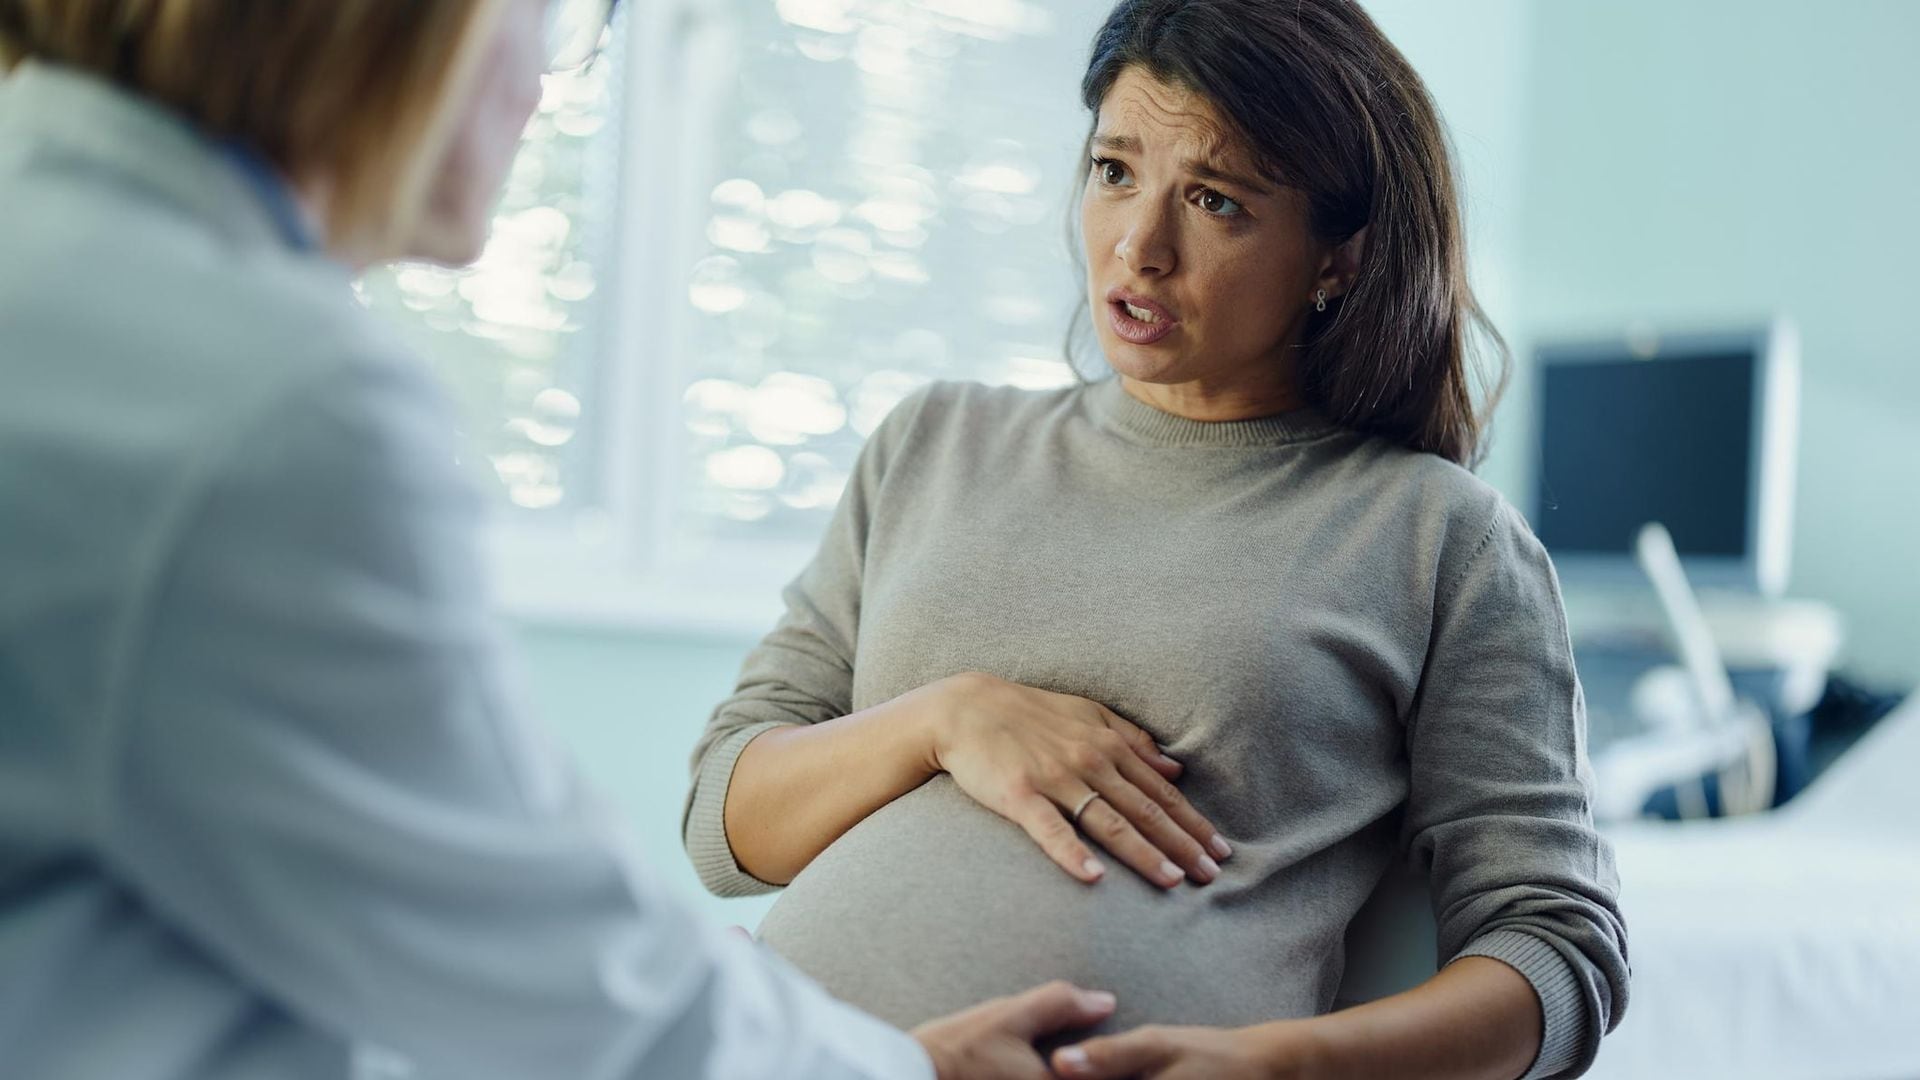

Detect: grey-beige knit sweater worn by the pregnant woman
[685,380,1628,1076]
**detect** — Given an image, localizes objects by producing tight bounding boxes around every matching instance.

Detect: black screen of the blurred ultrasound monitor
[1534,354,1755,557]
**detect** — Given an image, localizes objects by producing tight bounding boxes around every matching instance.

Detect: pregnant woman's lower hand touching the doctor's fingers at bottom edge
[1052,1020,1308,1080]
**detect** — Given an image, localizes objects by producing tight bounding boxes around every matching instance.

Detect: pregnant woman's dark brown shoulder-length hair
[1075,0,1511,467]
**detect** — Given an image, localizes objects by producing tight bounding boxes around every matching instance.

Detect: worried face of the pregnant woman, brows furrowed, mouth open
[1081,67,1338,411]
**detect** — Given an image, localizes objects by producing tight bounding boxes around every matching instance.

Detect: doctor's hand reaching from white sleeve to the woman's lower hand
[914,982,1114,1080]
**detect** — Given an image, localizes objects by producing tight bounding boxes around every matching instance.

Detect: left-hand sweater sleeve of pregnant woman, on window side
[680,382,931,896]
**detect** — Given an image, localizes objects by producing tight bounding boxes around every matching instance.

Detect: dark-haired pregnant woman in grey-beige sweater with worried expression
[685,0,1628,1078]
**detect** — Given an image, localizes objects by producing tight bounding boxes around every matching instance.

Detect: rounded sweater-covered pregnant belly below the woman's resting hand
[760,776,1340,1028]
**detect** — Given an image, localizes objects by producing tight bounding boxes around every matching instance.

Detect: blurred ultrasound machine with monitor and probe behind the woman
[1528,319,1841,819]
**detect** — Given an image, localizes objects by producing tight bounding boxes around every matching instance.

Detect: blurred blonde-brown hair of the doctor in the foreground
[0,0,503,259]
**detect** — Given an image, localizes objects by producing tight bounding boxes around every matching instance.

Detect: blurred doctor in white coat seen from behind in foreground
[0,0,1112,1080]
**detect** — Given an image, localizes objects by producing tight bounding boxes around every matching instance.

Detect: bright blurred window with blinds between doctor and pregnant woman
[365,0,1108,632]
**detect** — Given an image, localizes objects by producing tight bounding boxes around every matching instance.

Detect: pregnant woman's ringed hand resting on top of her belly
[916,673,1233,888]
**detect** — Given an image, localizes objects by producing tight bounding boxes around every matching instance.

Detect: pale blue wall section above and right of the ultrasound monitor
[1515,0,1920,684]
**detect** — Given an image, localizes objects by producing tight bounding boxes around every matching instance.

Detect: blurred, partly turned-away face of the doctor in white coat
[407,0,551,265]
